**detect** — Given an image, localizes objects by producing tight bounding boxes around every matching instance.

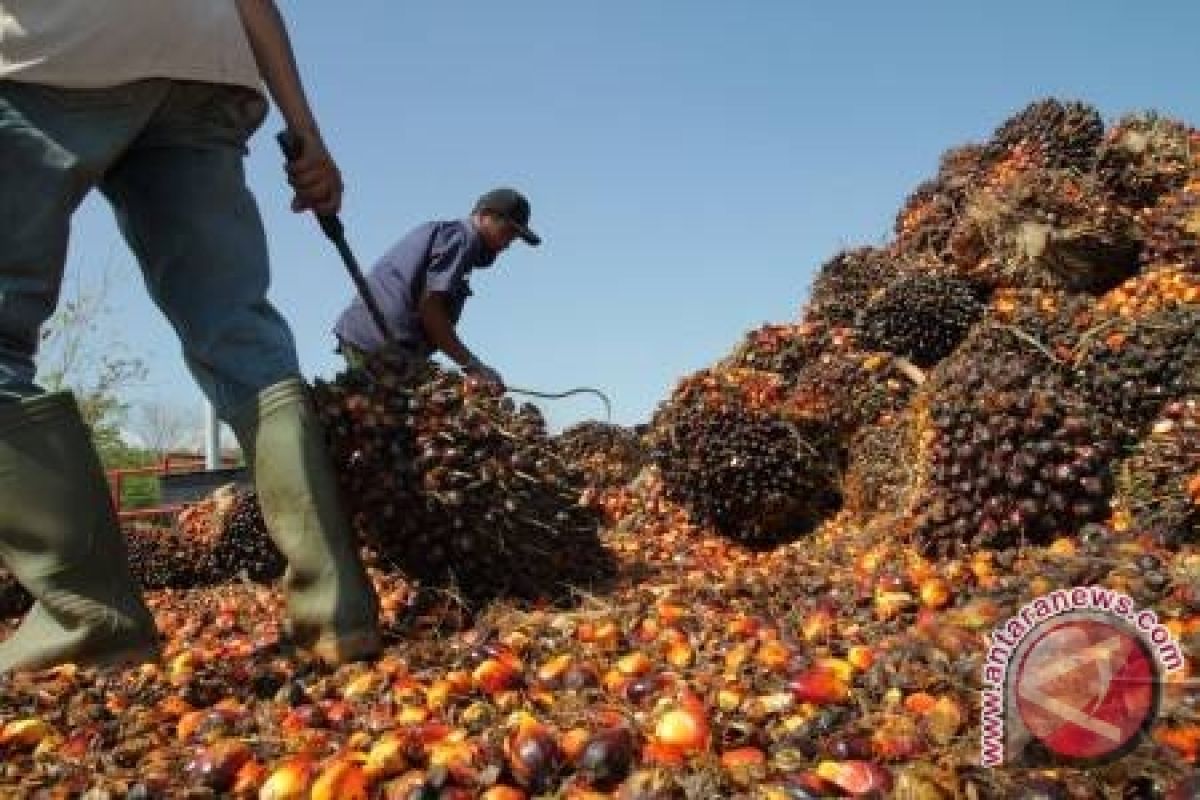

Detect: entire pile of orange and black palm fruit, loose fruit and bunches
[0,100,1200,800]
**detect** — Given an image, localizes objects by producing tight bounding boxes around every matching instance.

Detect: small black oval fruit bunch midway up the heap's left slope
[858,275,984,367]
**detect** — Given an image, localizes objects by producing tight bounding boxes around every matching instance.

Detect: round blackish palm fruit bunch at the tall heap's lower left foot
[653,405,840,542]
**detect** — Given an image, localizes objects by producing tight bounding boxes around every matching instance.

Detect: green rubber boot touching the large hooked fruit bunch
[230,378,380,663]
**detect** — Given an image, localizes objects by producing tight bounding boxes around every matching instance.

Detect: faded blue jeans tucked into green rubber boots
[0,80,300,420]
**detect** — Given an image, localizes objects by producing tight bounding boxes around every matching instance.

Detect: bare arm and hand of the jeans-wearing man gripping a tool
[238,0,342,213]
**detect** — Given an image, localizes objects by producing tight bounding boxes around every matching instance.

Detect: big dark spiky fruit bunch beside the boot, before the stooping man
[313,359,608,606]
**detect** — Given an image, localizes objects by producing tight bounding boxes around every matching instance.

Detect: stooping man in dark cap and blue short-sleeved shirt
[334,188,541,389]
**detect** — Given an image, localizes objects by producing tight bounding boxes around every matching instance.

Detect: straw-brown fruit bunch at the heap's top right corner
[1096,113,1200,209]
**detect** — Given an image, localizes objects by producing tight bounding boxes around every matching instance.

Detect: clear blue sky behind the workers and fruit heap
[60,0,1200,426]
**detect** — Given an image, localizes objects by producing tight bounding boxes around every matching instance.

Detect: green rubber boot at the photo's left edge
[0,392,158,672]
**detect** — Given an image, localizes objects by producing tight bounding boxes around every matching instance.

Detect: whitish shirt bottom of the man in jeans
[0,0,262,89]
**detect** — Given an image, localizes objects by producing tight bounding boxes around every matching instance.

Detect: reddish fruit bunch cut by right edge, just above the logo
[1114,396,1200,548]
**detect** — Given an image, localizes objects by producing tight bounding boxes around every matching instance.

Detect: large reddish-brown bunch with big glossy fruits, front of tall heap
[917,326,1121,554]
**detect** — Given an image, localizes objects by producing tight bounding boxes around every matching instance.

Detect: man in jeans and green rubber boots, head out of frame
[0,0,379,672]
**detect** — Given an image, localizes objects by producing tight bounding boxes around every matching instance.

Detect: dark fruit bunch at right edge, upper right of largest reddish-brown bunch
[1076,308,1200,432]
